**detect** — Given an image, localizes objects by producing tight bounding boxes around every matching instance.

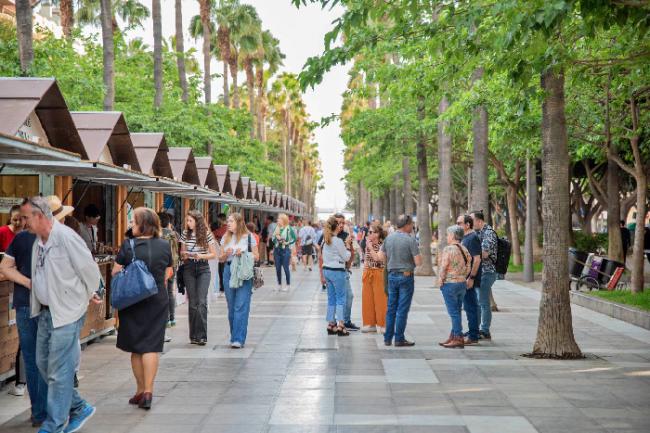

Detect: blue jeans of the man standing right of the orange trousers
[384,272,415,343]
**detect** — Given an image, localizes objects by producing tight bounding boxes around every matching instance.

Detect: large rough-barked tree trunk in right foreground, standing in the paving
[533,69,582,358]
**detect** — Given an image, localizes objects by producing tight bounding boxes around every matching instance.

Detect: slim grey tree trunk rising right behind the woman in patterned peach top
[438,96,451,253]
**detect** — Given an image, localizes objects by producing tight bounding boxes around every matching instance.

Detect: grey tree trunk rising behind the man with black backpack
[470,68,491,216]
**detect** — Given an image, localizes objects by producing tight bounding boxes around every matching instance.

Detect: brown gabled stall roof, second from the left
[70,111,140,171]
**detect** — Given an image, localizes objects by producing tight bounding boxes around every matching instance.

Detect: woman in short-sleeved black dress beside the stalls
[113,207,172,409]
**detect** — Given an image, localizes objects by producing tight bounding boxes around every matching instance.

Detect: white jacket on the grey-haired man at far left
[31,220,101,328]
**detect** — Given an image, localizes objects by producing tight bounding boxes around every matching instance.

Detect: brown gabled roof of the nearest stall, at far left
[0,78,88,159]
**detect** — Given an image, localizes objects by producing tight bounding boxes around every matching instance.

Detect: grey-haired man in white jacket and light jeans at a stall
[9,196,101,433]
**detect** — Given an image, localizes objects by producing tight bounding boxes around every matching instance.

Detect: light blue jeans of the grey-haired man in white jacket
[36,310,86,433]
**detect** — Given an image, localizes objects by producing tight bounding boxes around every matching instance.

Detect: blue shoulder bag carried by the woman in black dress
[111,239,158,310]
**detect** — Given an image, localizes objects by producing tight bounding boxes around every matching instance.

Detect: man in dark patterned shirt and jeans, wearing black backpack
[471,211,498,340]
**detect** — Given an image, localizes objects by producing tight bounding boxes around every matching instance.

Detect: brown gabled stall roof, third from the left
[131,132,174,179]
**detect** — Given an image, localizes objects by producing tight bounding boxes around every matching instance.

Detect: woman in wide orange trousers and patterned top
[361,221,388,333]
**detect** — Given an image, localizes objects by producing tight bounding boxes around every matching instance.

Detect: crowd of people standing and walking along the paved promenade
[0,196,512,433]
